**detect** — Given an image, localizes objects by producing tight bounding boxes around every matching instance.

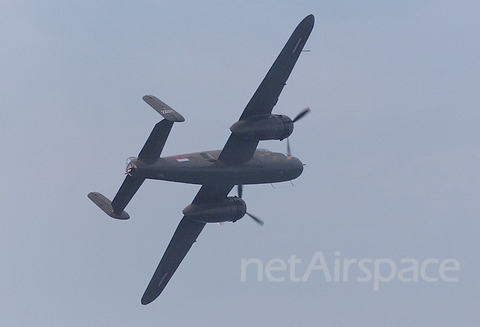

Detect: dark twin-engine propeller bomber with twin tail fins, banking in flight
[88,15,314,305]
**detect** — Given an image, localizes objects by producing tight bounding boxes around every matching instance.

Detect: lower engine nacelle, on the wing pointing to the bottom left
[183,197,247,223]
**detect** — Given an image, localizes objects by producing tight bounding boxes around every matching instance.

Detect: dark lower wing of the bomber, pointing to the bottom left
[142,183,234,305]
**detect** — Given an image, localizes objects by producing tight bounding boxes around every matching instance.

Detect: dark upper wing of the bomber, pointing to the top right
[218,15,315,165]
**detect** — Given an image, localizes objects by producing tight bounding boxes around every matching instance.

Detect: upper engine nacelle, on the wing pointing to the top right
[230,115,293,141]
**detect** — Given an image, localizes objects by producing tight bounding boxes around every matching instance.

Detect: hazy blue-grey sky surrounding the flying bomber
[0,0,480,326]
